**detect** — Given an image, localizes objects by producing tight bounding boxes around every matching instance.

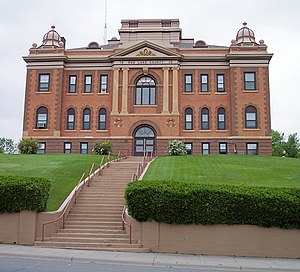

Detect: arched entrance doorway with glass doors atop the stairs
[133,125,156,156]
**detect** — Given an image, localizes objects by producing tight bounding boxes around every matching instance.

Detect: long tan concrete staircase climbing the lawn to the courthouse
[35,157,149,252]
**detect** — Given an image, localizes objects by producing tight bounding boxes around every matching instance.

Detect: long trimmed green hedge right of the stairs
[125,180,300,229]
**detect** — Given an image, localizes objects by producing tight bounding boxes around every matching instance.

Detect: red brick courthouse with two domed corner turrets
[23,19,272,155]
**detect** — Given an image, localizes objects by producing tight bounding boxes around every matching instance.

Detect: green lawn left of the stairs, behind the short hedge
[0,154,114,211]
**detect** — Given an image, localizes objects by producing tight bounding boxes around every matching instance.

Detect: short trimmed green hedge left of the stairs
[0,176,50,213]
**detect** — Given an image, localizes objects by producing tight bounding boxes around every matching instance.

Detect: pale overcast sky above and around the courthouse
[0,0,300,143]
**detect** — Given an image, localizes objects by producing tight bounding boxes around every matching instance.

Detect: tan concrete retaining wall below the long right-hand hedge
[127,216,300,258]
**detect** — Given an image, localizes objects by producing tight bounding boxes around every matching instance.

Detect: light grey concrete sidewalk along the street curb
[0,244,300,271]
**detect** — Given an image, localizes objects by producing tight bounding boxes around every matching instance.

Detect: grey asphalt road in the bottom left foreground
[0,257,237,272]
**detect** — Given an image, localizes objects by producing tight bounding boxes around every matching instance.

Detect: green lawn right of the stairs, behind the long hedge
[143,155,300,188]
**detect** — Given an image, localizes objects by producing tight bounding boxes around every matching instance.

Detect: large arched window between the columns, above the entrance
[135,76,156,105]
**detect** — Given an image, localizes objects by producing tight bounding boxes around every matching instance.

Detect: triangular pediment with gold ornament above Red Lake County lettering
[110,41,181,59]
